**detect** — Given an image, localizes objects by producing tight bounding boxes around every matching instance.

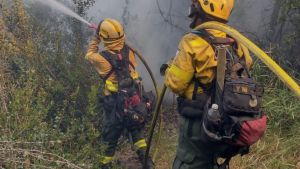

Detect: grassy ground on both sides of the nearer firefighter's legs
[156,83,300,169]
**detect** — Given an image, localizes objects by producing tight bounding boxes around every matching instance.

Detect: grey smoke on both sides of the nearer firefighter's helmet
[89,0,273,89]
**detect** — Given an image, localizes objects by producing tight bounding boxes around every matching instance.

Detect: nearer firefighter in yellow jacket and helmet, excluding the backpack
[165,0,252,169]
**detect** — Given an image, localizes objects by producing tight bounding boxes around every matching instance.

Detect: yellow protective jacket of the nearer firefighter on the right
[165,30,252,100]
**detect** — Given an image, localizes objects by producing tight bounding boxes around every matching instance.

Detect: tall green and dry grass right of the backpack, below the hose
[233,62,300,169]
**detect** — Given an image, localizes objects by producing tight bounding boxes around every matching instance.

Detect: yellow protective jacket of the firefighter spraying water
[85,38,139,95]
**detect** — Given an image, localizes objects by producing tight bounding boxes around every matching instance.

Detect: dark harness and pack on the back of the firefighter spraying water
[100,45,148,128]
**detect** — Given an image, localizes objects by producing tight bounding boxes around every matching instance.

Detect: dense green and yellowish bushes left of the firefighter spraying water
[0,0,102,168]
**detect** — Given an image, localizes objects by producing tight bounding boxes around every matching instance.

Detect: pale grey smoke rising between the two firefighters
[89,0,188,88]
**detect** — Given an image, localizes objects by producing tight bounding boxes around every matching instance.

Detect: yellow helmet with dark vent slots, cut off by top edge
[193,0,234,21]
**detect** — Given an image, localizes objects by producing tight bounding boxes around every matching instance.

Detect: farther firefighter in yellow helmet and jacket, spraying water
[86,19,153,169]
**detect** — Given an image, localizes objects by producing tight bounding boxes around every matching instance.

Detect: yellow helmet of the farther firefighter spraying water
[97,19,125,43]
